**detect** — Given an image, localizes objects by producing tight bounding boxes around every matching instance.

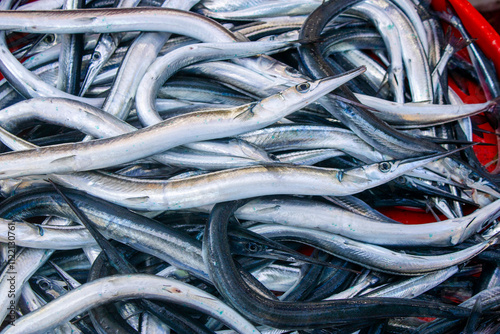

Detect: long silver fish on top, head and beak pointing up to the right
[0,68,364,178]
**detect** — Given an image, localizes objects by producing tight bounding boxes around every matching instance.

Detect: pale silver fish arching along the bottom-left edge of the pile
[3,274,258,334]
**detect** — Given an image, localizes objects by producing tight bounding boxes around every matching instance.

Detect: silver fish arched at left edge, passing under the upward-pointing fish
[0,98,274,170]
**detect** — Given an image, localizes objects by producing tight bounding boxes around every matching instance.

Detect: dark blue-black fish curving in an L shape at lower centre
[203,201,468,329]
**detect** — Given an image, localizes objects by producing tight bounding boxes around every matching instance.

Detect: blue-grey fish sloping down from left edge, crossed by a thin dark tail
[0,189,208,280]
